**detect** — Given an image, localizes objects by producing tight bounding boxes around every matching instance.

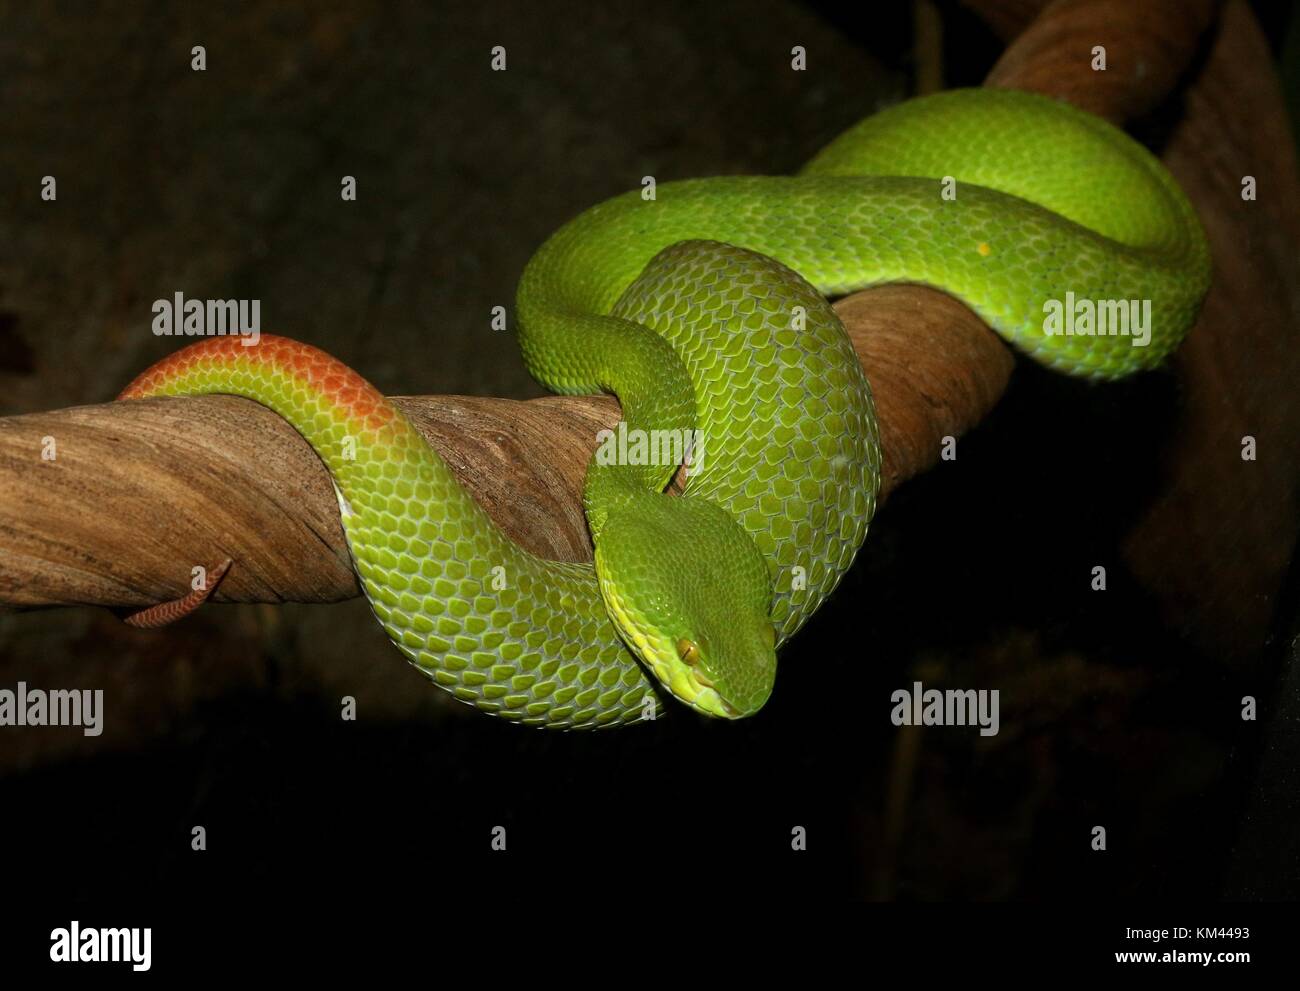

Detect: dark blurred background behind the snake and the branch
[0,0,1300,904]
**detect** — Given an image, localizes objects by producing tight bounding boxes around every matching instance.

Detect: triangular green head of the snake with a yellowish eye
[595,496,776,719]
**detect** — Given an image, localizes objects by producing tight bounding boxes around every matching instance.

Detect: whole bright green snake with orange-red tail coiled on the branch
[122,90,1209,728]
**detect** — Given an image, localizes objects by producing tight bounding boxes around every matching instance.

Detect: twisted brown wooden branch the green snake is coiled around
[0,3,1210,607]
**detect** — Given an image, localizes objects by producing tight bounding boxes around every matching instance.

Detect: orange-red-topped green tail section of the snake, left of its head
[120,334,658,728]
